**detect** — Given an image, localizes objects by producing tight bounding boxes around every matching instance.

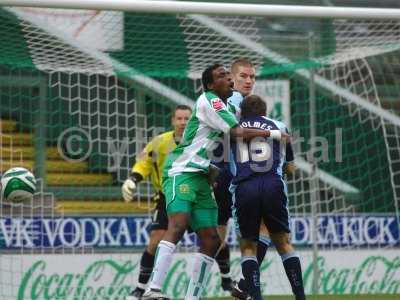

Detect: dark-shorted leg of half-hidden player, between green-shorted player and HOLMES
[214,173,236,291]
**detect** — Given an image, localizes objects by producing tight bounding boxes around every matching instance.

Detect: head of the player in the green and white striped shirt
[201,64,232,100]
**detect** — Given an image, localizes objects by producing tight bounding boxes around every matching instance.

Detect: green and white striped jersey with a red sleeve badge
[163,92,238,177]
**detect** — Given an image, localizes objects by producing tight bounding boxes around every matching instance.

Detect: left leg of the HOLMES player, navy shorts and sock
[232,179,262,299]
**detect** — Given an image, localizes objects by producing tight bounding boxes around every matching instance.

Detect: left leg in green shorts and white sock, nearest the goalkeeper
[143,174,195,299]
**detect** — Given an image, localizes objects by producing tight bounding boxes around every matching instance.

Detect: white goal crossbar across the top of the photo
[0,0,400,19]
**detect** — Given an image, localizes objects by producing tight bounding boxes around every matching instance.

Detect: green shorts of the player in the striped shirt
[163,173,218,231]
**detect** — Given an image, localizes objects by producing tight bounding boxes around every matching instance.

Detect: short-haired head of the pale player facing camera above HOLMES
[231,58,256,96]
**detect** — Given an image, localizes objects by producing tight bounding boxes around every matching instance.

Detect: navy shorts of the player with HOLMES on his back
[233,176,290,240]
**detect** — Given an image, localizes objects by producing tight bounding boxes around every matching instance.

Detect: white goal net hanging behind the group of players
[0,1,400,299]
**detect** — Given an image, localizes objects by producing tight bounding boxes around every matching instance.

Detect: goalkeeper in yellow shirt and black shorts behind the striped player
[122,105,192,300]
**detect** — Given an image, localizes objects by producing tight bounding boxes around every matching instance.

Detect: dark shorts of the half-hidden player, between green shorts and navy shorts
[214,170,232,225]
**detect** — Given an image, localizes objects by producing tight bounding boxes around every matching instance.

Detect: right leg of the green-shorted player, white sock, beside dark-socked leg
[185,178,221,300]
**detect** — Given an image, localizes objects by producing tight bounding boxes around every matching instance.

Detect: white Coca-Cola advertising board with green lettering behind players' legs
[14,250,400,300]
